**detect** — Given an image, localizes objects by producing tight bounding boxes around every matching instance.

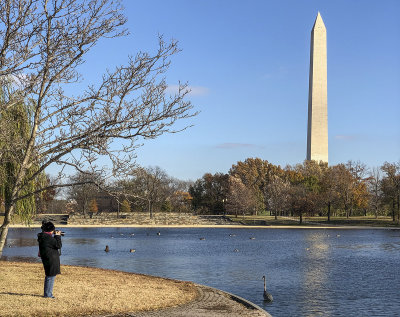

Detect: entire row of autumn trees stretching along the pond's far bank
[5,158,400,222]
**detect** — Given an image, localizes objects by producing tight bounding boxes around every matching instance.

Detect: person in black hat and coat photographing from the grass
[38,221,62,298]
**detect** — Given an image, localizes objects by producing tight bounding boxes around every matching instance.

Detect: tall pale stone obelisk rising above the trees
[307,12,328,162]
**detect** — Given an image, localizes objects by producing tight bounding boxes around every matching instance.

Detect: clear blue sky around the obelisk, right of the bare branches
[79,0,400,180]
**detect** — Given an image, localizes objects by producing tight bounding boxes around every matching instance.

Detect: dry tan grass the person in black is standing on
[0,261,197,316]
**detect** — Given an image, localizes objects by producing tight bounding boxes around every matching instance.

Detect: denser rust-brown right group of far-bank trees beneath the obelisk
[189,158,400,221]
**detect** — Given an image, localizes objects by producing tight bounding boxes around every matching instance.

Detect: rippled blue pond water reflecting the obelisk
[2,228,400,317]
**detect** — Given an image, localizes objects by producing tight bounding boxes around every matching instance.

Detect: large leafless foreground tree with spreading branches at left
[0,0,195,252]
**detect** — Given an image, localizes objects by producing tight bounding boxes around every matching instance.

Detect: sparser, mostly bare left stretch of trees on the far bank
[61,166,192,218]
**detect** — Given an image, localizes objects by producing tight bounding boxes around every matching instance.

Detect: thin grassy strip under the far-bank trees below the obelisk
[228,215,399,228]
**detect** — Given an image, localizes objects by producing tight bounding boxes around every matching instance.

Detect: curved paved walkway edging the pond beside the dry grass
[99,285,271,317]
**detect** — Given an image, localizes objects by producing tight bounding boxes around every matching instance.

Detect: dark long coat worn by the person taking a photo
[38,232,62,276]
